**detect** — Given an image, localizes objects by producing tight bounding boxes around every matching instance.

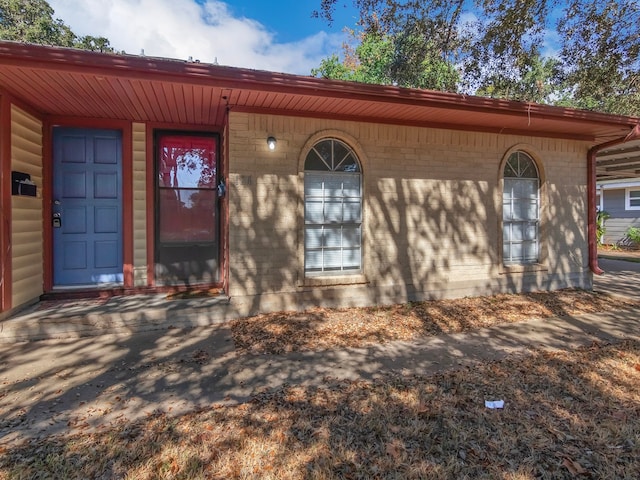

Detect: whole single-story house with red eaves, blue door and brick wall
[0,42,639,316]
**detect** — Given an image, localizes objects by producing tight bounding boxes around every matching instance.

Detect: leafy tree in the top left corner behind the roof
[0,0,113,52]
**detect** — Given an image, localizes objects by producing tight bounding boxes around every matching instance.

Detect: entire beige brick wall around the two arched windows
[229,112,591,311]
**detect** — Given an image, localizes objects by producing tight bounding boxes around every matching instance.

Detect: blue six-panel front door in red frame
[51,128,123,286]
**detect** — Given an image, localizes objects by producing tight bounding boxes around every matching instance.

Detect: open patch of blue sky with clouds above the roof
[49,0,357,75]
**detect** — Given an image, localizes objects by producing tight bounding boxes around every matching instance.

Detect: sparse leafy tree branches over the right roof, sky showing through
[314,0,640,115]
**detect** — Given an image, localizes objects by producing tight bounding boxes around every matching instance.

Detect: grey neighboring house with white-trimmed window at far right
[596,179,640,245]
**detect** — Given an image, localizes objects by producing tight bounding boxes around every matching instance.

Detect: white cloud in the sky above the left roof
[49,0,343,75]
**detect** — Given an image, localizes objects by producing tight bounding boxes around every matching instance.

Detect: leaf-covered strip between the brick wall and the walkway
[231,289,640,354]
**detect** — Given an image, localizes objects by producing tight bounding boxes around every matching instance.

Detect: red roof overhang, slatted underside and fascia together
[0,42,640,153]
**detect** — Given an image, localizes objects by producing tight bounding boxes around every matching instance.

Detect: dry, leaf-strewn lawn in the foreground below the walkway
[0,341,640,480]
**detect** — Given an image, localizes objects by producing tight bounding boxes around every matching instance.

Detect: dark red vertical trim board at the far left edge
[0,94,12,312]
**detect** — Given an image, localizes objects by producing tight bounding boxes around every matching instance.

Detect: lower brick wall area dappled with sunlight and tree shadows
[230,149,591,313]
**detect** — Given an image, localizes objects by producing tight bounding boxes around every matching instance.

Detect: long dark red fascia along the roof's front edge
[0,42,638,128]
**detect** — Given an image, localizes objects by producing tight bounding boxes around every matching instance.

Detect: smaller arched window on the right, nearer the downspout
[502,151,540,265]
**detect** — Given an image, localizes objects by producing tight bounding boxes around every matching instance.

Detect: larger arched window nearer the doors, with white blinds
[304,138,362,275]
